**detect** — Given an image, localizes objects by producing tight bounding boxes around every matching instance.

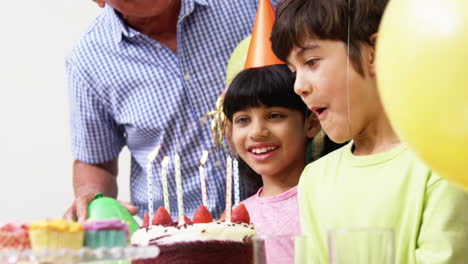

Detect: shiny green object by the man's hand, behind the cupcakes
[88,193,140,235]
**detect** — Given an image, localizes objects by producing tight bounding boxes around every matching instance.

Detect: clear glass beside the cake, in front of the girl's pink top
[252,236,319,264]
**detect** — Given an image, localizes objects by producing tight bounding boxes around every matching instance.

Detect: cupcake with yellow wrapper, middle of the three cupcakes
[29,219,84,251]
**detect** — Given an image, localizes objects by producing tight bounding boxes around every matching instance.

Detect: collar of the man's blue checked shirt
[104,0,208,43]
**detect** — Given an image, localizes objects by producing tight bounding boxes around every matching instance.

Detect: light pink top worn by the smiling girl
[242,186,301,264]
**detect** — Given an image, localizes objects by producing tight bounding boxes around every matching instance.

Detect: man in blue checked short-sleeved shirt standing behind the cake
[65,0,278,220]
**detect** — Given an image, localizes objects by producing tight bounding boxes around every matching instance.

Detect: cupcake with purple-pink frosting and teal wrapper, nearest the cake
[84,219,128,249]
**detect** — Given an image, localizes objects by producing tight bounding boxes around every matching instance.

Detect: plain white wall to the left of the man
[0,0,129,222]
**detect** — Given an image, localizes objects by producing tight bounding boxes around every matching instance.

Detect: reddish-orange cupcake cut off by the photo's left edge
[0,224,31,251]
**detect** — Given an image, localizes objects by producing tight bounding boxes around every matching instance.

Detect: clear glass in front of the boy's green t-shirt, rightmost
[328,228,395,264]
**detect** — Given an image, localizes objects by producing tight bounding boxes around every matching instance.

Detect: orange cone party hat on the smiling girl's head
[244,0,284,69]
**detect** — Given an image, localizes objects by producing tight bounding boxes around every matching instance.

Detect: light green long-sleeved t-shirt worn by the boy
[299,142,468,264]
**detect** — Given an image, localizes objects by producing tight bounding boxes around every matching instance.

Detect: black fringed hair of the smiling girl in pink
[223,64,308,122]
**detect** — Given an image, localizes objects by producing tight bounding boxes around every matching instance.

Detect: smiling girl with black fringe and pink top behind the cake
[223,65,337,263]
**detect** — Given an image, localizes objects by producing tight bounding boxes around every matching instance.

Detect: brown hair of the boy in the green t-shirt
[271,0,388,75]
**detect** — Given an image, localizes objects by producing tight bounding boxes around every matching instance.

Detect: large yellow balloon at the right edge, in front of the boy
[376,0,468,189]
